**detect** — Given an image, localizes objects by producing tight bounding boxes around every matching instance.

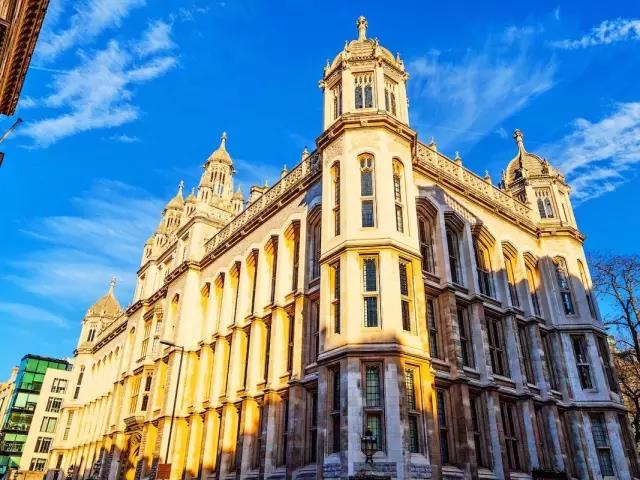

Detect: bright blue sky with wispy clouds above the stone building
[0,0,640,378]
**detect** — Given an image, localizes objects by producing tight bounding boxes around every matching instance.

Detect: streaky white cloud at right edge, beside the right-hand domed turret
[541,102,640,204]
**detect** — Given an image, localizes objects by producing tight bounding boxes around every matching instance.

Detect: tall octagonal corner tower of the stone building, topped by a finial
[317,17,433,478]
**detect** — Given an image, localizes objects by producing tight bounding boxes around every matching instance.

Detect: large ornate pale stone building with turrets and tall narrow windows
[43,18,638,480]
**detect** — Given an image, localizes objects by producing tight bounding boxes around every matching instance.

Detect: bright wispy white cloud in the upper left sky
[21,34,178,147]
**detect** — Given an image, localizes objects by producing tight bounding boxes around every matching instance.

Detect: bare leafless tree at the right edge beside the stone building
[590,255,640,445]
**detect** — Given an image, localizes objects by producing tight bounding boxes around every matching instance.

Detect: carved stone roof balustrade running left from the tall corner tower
[205,153,322,253]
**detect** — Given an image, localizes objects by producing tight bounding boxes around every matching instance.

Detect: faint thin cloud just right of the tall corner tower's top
[408,26,556,149]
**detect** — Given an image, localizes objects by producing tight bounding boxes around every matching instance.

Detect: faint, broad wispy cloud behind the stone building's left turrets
[3,180,164,307]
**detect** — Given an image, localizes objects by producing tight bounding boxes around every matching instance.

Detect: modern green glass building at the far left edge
[0,354,71,476]
